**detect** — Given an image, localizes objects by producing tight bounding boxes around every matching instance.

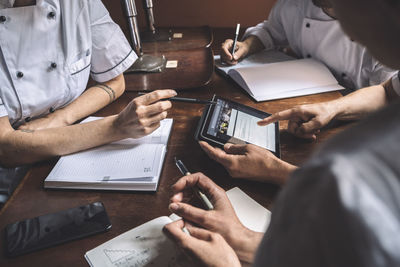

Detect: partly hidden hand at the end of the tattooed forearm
[18,109,73,131]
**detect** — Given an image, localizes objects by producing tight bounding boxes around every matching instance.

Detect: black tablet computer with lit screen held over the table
[195,96,280,157]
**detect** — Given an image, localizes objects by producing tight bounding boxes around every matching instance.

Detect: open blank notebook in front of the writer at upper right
[215,50,343,101]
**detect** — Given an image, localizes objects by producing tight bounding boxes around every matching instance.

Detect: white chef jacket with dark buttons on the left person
[0,0,137,127]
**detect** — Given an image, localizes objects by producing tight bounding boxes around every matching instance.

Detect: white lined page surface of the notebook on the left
[46,143,165,182]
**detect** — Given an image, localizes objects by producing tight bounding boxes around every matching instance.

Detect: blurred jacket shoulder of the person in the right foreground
[254,101,400,267]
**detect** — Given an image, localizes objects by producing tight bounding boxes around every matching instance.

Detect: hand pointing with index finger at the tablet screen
[258,102,336,140]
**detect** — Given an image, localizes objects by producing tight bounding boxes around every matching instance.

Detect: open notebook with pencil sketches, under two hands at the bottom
[85,187,271,267]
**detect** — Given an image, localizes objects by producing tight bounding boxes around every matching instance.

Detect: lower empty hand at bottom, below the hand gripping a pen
[164,220,241,267]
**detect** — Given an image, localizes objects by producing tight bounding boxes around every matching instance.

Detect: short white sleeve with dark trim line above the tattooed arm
[88,0,137,82]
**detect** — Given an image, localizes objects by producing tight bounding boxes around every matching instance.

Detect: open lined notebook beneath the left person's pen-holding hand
[44,117,173,191]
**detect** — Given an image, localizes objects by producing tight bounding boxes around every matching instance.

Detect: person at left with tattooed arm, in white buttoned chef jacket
[0,0,176,203]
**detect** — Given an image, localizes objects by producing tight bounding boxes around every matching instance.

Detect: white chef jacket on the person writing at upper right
[243,0,395,90]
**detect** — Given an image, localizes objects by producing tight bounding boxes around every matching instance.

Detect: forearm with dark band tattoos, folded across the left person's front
[54,74,125,125]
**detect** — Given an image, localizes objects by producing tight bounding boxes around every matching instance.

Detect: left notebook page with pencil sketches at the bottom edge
[85,217,191,267]
